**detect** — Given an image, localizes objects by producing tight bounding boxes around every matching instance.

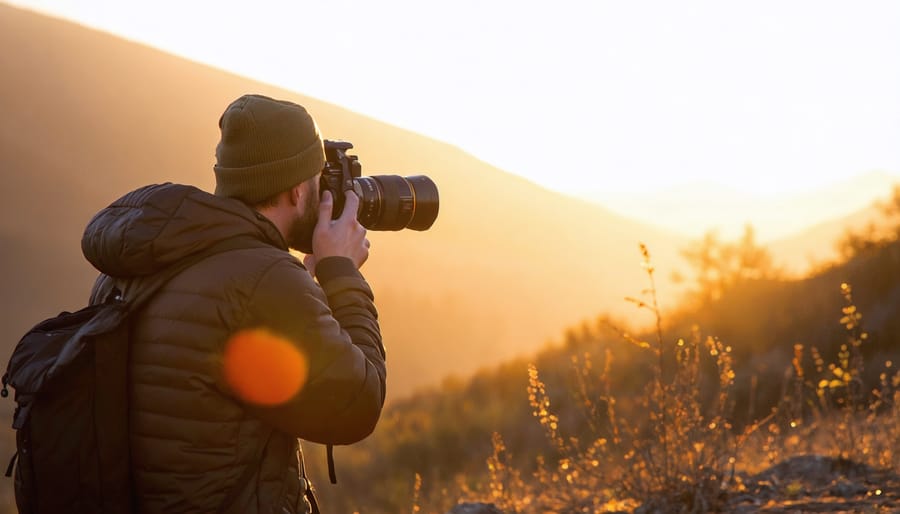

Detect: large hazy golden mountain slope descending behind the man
[0,5,684,398]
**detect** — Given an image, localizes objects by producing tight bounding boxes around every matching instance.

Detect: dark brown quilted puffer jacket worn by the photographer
[82,184,386,514]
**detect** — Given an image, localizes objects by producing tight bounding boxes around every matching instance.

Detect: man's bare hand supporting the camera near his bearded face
[303,191,369,276]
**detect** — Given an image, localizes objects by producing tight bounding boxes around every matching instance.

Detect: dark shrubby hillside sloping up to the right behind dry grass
[313,233,900,512]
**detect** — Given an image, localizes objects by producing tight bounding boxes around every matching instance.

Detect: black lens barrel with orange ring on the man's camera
[353,175,440,230]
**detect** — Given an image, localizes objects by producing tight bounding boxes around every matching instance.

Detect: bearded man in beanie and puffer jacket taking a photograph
[82,95,386,514]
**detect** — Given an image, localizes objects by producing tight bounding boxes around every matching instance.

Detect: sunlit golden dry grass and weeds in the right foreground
[458,245,900,514]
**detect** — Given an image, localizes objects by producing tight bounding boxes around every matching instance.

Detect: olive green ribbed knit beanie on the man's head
[213,95,325,205]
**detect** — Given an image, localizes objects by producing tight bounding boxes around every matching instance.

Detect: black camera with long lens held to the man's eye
[319,139,439,230]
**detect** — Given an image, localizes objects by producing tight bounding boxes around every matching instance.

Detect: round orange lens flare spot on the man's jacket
[223,329,309,405]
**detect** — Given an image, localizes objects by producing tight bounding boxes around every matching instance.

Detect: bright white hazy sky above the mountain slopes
[9,0,900,201]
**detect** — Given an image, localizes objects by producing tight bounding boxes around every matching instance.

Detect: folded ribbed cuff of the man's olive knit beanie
[213,141,325,205]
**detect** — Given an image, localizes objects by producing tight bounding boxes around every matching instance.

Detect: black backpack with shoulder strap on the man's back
[0,240,262,514]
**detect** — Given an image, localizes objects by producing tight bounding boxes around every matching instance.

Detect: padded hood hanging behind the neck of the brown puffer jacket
[81,183,287,278]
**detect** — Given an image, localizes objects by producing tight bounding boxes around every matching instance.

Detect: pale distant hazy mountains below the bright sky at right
[585,172,900,277]
